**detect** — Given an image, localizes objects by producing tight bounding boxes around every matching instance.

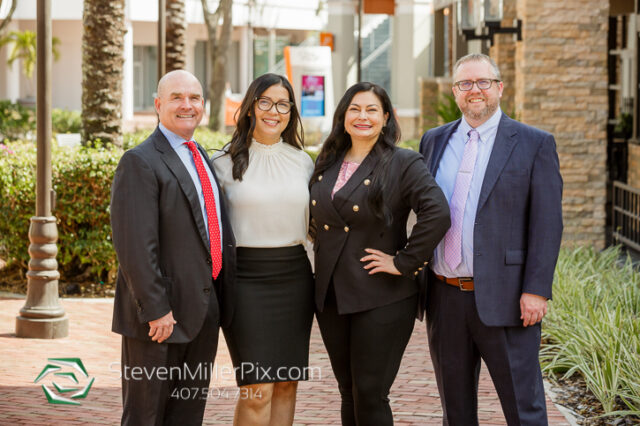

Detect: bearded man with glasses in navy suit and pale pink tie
[420,54,562,426]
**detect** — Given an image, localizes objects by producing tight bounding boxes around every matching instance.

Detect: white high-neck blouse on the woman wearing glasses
[213,139,314,247]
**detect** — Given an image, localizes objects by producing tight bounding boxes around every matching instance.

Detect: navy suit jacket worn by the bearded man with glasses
[420,114,562,326]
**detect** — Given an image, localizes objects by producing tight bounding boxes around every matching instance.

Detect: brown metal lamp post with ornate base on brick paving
[16,0,69,339]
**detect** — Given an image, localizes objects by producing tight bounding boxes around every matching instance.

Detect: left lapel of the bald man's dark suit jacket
[153,129,209,250]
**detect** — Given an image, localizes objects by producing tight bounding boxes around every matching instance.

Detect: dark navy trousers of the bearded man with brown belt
[427,275,548,426]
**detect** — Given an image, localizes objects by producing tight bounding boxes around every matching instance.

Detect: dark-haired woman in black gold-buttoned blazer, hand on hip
[310,82,450,425]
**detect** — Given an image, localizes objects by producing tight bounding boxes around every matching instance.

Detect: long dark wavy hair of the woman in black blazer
[310,82,400,225]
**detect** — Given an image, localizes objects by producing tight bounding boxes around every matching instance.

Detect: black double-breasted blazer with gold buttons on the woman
[311,149,450,314]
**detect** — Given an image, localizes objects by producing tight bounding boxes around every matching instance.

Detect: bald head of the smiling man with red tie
[155,70,204,140]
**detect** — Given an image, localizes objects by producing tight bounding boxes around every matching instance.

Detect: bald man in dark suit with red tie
[111,71,235,425]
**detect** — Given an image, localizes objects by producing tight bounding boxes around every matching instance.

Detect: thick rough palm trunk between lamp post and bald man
[82,0,125,146]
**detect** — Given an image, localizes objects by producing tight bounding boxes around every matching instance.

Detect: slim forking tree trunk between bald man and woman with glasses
[202,0,233,132]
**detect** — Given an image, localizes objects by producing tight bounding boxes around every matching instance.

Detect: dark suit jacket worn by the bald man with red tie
[111,128,235,343]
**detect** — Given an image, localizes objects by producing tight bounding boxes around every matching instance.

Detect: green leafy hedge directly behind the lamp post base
[0,143,122,286]
